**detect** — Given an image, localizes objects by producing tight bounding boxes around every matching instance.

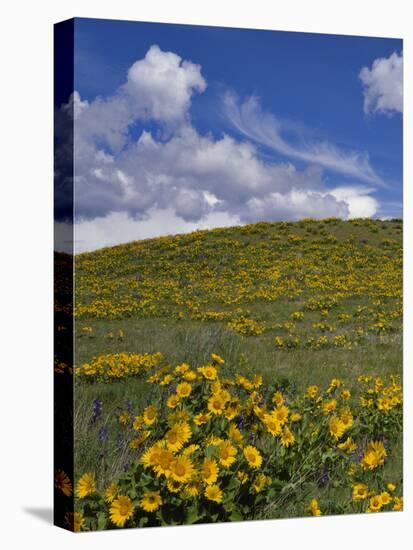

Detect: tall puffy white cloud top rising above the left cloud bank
[72,45,206,152]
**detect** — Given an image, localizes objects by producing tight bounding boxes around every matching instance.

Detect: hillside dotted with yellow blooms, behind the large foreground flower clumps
[75,219,402,390]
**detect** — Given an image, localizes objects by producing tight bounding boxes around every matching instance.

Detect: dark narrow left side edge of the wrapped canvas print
[54,20,76,530]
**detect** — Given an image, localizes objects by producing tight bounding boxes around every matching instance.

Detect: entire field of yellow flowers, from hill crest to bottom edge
[55,218,403,531]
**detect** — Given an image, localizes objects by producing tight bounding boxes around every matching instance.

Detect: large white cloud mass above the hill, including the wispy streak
[57,45,380,252]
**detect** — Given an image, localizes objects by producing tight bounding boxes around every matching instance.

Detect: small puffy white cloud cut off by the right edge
[359,52,403,114]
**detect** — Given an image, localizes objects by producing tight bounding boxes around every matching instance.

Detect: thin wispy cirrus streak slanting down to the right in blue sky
[224,92,386,187]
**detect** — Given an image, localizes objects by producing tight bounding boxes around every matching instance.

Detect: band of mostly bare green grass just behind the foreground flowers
[76,319,402,394]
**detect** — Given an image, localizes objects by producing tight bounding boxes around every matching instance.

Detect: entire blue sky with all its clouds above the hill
[57,19,403,249]
